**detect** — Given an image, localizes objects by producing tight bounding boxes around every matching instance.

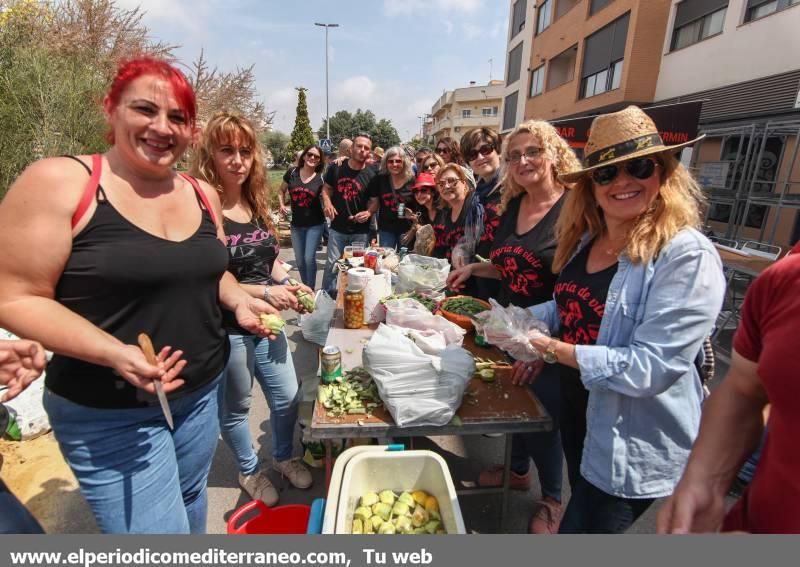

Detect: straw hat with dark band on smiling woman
[558,106,705,183]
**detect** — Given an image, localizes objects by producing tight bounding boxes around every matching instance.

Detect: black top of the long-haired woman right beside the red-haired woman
[222,217,281,335]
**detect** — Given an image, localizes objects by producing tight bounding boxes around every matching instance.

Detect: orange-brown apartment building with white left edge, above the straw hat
[501,0,672,131]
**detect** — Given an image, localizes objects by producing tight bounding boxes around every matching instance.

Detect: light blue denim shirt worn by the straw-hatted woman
[530,229,725,498]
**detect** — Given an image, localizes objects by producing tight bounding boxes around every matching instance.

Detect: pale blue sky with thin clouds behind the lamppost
[117,0,509,140]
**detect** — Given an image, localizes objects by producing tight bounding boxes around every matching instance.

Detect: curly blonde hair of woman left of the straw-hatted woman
[499,120,581,214]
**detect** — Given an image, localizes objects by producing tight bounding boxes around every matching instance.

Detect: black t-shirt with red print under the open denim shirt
[554,240,619,345]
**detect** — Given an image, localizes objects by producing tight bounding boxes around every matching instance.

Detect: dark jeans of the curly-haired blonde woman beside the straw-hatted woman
[511,364,564,502]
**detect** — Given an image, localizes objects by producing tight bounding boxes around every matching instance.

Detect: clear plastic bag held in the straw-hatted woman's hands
[474,299,550,362]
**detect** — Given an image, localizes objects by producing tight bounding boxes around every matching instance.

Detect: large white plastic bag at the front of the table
[363,325,475,427]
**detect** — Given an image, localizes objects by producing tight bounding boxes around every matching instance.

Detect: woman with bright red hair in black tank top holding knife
[0,57,276,533]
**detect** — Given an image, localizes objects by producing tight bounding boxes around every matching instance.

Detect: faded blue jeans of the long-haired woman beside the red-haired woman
[219,333,300,474]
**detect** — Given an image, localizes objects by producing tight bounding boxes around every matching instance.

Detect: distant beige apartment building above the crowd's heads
[430,81,503,140]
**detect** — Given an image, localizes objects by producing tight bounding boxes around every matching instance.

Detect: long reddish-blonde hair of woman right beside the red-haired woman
[189,112,277,236]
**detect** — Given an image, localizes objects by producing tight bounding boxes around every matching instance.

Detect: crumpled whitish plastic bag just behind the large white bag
[386,298,466,354]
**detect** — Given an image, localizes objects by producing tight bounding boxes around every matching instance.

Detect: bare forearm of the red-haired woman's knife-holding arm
[0,296,122,366]
